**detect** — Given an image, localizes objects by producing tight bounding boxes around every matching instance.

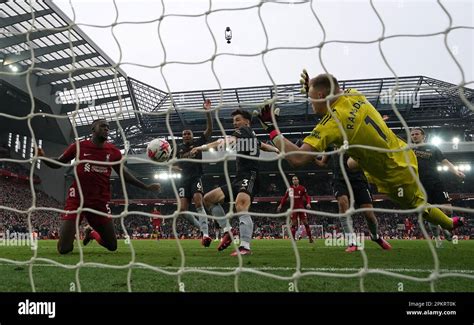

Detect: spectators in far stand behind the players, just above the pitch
[112,202,472,239]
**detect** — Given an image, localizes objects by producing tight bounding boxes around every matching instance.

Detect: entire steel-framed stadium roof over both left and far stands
[0,0,474,145]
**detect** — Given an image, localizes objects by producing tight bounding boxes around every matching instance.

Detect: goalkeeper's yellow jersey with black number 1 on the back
[304,89,418,193]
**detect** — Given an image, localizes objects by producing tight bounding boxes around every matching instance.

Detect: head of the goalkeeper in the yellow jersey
[308,73,340,115]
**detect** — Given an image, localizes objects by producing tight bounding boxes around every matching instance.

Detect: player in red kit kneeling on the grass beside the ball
[38,119,160,254]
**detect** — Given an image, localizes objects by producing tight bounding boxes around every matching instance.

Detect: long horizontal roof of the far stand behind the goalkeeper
[121,76,474,146]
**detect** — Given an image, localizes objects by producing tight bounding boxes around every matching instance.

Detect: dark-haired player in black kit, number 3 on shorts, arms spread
[191,110,278,256]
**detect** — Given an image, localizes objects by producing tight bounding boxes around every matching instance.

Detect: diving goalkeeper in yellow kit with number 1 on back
[258,71,464,230]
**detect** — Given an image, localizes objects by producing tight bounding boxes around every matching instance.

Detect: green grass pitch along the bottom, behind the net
[0,240,474,292]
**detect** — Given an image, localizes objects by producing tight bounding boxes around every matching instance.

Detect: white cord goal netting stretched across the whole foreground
[0,1,474,291]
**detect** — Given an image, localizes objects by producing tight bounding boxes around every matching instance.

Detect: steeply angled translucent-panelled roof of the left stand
[0,0,134,142]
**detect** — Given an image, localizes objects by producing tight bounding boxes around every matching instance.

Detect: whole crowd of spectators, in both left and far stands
[0,162,472,238]
